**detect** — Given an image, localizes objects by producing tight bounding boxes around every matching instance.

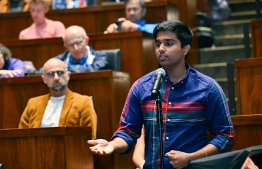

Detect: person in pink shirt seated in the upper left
[19,0,65,39]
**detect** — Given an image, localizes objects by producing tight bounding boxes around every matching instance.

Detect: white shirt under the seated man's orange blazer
[40,96,65,127]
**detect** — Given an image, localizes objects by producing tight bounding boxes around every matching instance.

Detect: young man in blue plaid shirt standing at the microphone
[88,20,234,169]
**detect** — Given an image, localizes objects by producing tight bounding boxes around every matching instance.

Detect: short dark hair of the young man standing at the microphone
[153,20,193,53]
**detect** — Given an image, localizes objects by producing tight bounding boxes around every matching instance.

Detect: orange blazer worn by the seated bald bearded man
[19,89,97,139]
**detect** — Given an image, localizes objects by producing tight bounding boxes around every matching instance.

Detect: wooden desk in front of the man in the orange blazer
[0,127,94,169]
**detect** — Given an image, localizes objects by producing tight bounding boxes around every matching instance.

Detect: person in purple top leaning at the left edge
[0,44,25,78]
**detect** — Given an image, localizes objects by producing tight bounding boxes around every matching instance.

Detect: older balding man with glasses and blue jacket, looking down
[56,25,108,72]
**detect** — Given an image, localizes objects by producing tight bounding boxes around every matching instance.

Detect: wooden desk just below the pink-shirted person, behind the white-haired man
[1,31,158,83]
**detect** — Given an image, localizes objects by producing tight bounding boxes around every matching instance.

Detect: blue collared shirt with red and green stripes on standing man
[112,64,234,169]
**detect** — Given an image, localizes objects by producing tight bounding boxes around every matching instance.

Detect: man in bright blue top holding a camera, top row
[106,0,158,34]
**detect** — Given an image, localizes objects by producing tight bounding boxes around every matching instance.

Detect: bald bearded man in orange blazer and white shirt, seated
[19,58,97,139]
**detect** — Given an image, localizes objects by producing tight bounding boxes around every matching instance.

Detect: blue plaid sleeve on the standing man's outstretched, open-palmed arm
[112,81,143,154]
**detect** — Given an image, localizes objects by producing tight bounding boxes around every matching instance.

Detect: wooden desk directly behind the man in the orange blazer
[0,70,133,169]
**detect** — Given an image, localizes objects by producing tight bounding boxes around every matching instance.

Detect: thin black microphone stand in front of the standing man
[156,91,164,169]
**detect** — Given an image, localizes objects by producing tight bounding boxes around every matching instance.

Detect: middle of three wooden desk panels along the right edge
[235,58,262,115]
